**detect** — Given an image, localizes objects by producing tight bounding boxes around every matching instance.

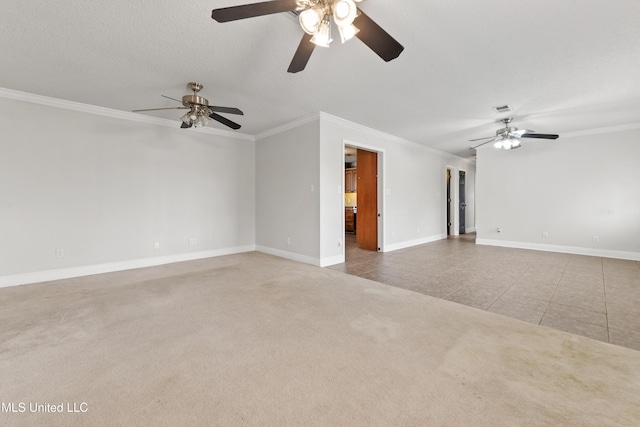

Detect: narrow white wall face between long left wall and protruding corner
[255,118,320,264]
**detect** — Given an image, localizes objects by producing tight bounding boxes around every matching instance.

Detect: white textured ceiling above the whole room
[0,0,640,157]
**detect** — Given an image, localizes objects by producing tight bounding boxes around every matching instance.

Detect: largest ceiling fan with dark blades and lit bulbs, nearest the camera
[211,0,404,73]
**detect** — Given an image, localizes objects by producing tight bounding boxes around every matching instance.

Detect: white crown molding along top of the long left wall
[0,88,255,141]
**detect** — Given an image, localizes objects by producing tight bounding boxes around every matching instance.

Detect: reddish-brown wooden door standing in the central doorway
[356,149,378,251]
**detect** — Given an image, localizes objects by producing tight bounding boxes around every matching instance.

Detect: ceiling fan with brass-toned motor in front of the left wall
[133,82,244,129]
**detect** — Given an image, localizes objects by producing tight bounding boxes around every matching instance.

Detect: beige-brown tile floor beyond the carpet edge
[329,233,640,350]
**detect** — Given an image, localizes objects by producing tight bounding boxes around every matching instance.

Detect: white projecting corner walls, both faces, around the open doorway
[256,113,475,266]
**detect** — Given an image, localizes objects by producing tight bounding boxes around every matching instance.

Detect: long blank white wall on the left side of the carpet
[0,98,255,285]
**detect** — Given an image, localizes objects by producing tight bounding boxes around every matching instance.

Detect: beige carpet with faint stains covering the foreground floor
[0,253,640,426]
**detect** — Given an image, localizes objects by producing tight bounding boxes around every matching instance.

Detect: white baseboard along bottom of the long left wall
[0,245,256,288]
